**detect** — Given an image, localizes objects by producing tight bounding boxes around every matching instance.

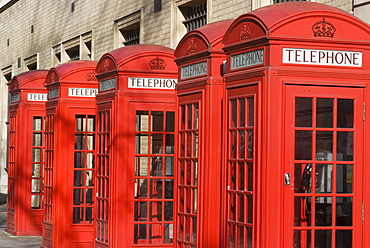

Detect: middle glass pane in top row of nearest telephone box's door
[316,98,333,127]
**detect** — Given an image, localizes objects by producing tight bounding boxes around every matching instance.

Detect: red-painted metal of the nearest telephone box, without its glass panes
[223,2,370,248]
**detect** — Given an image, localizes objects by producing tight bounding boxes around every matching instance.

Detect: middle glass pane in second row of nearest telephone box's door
[316,132,333,161]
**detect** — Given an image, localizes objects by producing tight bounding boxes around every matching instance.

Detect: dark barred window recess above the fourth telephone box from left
[180,3,207,32]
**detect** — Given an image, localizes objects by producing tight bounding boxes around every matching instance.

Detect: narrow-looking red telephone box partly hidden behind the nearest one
[175,20,232,248]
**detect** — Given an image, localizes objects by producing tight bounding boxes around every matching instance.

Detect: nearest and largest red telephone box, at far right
[223,2,370,248]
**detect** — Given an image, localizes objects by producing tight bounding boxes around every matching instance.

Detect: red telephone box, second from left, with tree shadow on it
[42,60,98,248]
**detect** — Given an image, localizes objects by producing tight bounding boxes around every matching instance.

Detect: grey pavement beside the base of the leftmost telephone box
[0,204,42,248]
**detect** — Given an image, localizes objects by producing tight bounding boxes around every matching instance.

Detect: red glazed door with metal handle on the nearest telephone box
[283,86,364,248]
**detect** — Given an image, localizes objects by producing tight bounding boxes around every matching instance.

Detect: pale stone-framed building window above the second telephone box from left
[52,31,93,66]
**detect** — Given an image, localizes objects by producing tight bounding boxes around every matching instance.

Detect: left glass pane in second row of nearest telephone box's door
[295,131,312,160]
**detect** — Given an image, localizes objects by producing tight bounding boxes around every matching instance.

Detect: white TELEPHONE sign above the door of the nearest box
[283,48,362,67]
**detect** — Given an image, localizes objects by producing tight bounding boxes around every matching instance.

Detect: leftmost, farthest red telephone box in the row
[6,70,48,236]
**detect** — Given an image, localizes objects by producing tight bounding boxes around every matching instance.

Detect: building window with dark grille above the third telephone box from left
[114,10,141,48]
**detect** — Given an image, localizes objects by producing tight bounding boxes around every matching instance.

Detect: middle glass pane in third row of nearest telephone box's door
[315,164,333,193]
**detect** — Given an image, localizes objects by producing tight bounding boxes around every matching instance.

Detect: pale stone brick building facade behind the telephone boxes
[0,0,362,200]
